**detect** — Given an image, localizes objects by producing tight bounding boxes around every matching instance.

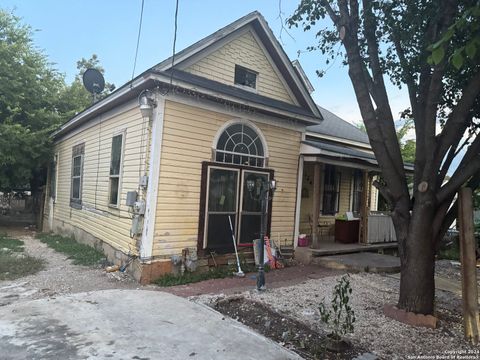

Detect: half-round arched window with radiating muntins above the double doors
[215,123,265,167]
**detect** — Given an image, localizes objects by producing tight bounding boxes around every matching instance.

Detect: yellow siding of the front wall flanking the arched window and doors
[153,101,301,256]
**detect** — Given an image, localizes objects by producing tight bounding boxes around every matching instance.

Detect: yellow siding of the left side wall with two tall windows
[49,107,148,253]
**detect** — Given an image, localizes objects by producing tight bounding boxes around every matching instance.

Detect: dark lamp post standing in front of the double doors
[247,178,277,291]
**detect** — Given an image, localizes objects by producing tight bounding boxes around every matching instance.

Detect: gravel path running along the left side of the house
[0,227,140,306]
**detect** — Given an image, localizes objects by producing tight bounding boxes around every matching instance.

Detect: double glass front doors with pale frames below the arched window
[202,165,271,251]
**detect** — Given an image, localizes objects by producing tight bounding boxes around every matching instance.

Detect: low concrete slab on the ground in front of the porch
[312,252,400,273]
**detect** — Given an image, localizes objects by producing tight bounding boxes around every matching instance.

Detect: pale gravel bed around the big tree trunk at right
[192,273,480,359]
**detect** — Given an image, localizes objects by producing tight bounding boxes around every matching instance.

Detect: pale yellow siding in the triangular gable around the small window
[185,31,294,104]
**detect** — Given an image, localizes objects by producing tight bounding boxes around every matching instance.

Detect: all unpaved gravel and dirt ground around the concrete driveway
[0,227,480,359]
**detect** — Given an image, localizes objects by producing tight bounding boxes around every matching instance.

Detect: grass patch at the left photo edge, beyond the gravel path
[0,234,45,280]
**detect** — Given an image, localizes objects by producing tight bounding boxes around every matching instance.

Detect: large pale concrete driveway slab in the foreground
[0,290,301,360]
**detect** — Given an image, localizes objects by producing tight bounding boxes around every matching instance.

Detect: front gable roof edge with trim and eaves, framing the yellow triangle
[53,11,322,141]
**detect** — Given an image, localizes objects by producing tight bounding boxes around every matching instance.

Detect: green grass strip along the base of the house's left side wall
[37,233,105,266]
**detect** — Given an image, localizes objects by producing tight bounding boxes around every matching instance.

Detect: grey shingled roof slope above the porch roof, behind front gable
[307,105,370,146]
